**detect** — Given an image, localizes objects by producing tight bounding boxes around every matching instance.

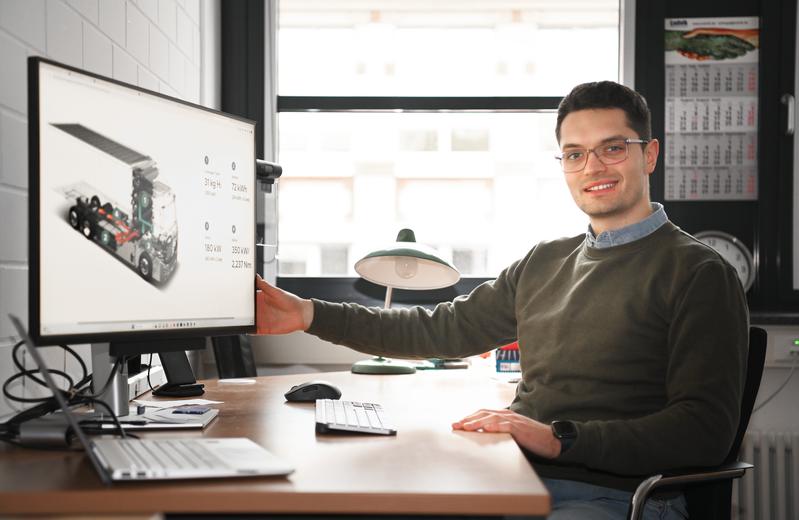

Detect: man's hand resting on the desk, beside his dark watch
[452,410,560,459]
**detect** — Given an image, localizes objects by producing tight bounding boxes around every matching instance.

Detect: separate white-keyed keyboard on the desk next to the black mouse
[316,399,397,435]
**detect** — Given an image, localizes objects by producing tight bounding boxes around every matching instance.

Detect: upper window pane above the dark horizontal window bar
[277,0,619,96]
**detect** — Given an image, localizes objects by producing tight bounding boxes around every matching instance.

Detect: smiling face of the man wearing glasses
[560,108,658,233]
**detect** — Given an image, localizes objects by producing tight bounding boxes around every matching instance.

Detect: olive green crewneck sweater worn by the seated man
[308,222,749,490]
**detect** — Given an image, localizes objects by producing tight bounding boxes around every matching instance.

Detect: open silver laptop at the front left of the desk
[9,314,294,485]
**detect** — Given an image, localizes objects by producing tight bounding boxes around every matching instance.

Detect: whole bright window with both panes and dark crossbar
[277,0,619,284]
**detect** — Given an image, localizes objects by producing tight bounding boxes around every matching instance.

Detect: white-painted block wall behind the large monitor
[0,0,209,417]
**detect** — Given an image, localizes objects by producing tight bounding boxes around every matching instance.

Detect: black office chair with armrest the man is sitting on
[627,327,767,520]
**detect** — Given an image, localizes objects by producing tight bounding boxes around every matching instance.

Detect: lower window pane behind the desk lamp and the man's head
[278,112,588,276]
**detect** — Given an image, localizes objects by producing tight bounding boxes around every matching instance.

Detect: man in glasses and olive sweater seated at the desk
[257,82,748,519]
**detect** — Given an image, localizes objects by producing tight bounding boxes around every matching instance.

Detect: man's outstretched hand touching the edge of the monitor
[255,275,313,334]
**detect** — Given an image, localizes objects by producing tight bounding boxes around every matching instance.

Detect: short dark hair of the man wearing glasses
[555,81,652,142]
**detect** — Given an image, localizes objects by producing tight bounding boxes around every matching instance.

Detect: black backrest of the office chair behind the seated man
[685,327,768,520]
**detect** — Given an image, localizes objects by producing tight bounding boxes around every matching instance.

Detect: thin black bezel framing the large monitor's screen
[28,56,258,345]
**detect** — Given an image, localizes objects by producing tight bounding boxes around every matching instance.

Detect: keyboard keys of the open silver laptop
[118,439,227,470]
